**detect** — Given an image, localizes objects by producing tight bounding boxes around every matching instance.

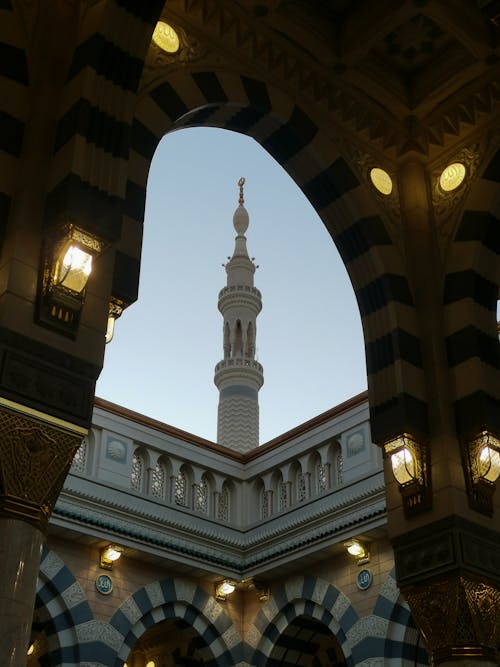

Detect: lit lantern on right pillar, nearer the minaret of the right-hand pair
[384,433,432,517]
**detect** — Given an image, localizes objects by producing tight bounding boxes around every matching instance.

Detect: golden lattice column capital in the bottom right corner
[402,576,500,664]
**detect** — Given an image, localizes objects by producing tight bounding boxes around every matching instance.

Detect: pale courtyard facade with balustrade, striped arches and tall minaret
[28,178,422,667]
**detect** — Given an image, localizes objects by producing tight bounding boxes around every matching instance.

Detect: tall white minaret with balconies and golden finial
[214,178,264,452]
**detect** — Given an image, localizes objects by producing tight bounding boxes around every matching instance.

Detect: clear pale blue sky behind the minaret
[96,128,366,443]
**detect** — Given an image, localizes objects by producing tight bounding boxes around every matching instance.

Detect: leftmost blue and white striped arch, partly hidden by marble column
[33,547,98,667]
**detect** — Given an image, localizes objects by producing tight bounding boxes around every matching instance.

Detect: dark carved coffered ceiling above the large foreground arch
[161,0,500,157]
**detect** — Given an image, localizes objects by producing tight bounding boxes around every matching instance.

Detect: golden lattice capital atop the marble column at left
[0,407,83,530]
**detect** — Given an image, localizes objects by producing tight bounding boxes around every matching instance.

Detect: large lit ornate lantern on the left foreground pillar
[38,223,106,338]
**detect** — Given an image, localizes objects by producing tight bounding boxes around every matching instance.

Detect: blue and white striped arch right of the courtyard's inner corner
[247,576,358,667]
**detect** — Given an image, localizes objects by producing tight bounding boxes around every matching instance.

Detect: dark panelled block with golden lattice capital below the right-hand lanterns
[394,517,500,667]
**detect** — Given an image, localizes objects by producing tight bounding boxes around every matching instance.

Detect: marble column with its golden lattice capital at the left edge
[0,404,86,667]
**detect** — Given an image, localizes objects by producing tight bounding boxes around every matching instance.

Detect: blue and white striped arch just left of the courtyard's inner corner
[110,577,243,667]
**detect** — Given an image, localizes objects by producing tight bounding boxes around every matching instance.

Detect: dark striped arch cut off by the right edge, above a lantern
[443,149,500,440]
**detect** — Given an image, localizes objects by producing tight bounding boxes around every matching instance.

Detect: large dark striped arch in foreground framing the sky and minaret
[26,0,428,454]
